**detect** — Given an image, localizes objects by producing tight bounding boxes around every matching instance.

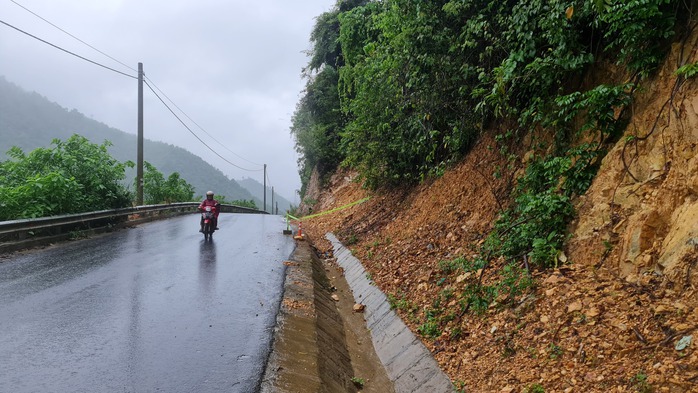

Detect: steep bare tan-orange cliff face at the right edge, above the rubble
[570,36,698,282]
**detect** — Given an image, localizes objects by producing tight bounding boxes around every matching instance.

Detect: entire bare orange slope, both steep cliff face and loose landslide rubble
[303,36,698,392]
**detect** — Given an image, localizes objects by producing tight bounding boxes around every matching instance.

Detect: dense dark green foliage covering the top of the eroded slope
[292,0,683,190]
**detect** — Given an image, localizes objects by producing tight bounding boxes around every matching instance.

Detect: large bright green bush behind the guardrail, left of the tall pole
[0,135,132,220]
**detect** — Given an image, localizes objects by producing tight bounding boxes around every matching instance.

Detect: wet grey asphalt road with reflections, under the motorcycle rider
[0,214,294,393]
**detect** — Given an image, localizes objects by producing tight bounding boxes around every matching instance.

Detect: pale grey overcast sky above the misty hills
[0,0,336,203]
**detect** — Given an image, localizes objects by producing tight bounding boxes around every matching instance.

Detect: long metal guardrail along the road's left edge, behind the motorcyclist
[0,202,268,252]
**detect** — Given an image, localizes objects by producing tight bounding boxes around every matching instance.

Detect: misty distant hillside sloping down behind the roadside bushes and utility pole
[0,76,264,205]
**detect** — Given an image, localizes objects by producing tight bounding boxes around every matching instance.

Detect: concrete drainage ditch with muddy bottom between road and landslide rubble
[260,233,455,393]
